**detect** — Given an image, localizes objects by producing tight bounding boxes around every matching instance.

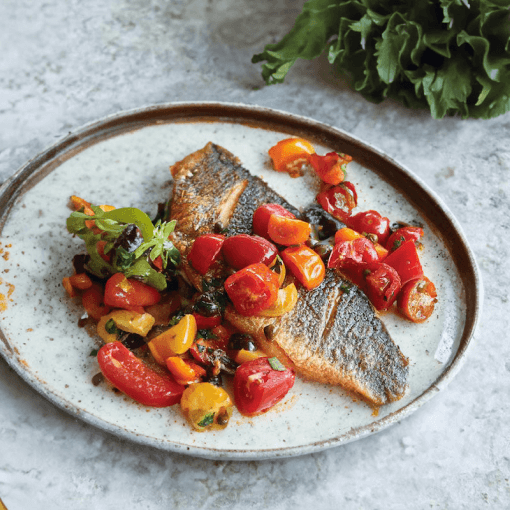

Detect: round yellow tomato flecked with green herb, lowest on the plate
[181,382,232,432]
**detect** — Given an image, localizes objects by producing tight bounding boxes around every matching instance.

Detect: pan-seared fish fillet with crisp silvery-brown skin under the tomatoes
[170,143,409,406]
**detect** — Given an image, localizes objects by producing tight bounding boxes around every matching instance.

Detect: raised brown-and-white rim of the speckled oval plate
[0,101,483,460]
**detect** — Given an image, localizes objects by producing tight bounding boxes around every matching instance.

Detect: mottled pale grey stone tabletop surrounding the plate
[0,0,510,510]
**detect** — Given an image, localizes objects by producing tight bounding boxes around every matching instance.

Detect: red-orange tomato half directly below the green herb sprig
[104,273,161,313]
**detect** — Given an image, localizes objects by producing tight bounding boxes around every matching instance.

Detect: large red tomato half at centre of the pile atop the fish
[225,263,279,316]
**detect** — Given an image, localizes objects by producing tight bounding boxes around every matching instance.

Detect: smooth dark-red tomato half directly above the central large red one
[221,234,278,269]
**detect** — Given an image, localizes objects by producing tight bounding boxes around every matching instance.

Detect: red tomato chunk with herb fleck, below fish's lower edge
[234,358,296,416]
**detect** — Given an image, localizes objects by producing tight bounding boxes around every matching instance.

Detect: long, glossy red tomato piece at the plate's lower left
[97,342,184,407]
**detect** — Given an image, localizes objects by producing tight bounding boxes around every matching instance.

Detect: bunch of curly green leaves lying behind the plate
[252,0,510,119]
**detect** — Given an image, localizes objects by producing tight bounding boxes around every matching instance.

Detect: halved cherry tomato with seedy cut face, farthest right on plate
[397,276,437,322]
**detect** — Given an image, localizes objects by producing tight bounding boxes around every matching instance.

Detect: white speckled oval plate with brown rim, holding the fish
[0,103,481,460]
